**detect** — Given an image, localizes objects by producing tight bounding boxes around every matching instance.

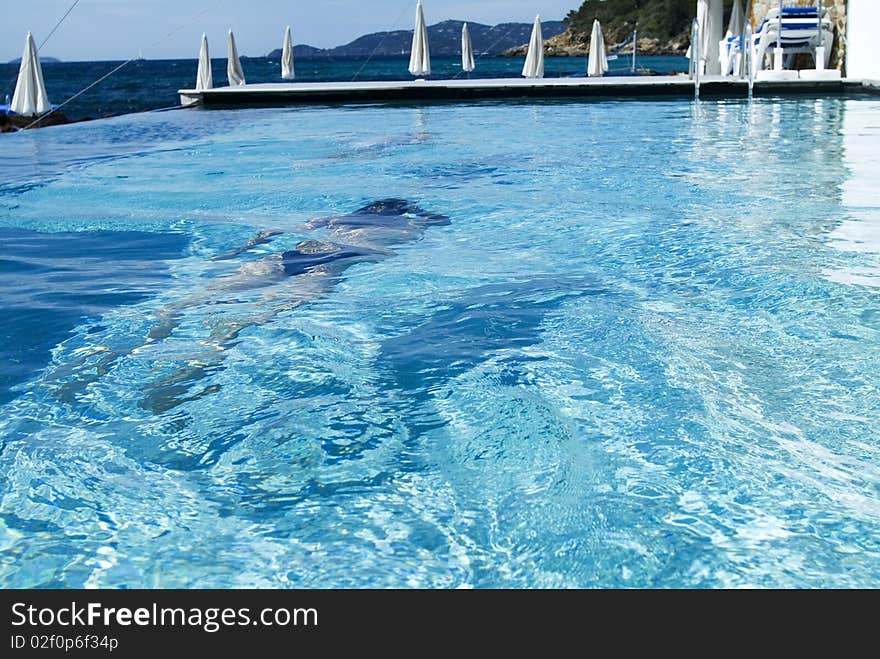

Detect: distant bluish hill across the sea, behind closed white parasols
[268,21,566,59]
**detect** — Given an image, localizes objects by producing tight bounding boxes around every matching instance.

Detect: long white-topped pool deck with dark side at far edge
[179,72,878,107]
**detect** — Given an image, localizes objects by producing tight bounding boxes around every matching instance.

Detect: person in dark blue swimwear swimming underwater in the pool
[44,198,450,411]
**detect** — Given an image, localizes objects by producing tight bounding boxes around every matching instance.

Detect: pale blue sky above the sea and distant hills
[0,0,581,62]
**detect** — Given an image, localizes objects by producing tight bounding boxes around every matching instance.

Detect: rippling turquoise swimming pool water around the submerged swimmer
[0,99,880,587]
